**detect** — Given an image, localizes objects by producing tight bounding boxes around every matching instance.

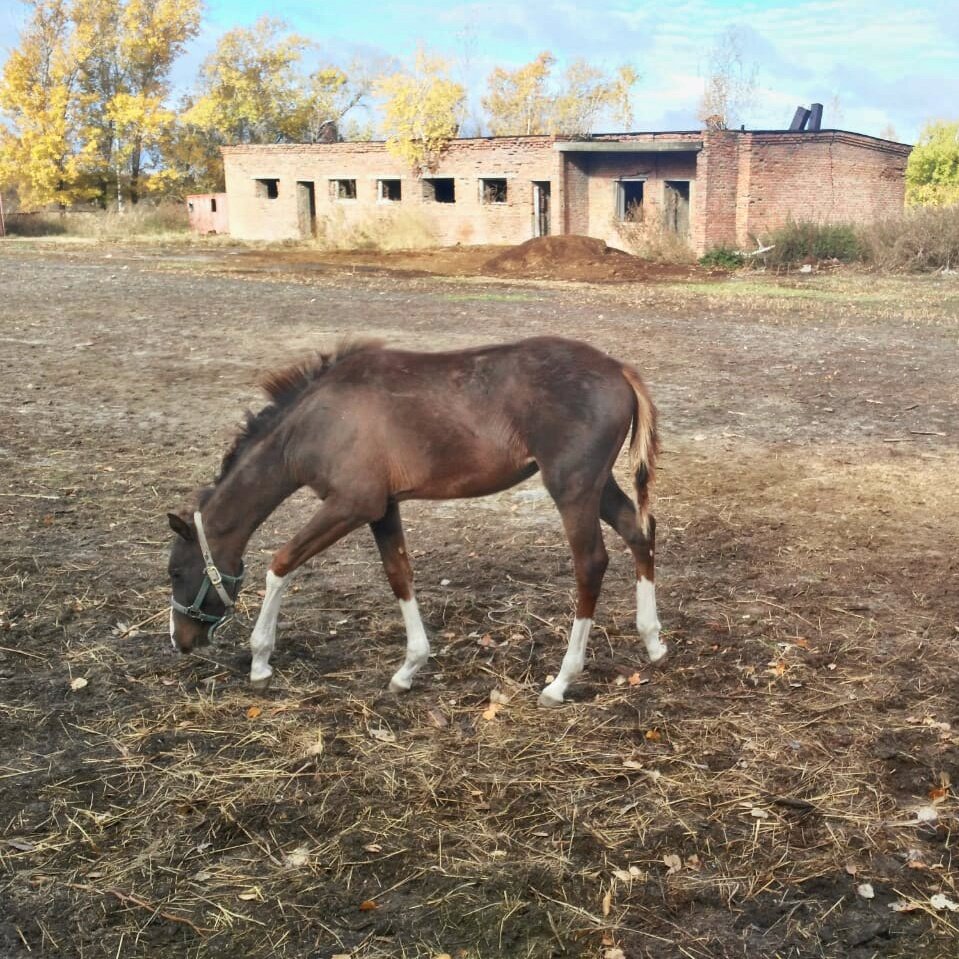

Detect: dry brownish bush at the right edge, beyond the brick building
[861,204,959,273]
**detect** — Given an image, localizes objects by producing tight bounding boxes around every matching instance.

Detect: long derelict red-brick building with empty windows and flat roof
[222,130,911,254]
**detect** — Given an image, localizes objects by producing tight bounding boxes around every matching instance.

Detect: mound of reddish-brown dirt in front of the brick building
[483,235,706,283]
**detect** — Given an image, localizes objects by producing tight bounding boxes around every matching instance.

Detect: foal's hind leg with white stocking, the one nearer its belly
[539,497,609,706]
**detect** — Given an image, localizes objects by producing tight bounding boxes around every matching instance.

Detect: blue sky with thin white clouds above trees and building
[0,0,959,141]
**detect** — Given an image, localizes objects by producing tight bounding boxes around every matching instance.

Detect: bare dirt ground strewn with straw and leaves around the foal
[0,243,959,959]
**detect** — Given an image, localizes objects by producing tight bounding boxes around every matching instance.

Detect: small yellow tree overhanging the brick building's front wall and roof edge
[375,48,466,170]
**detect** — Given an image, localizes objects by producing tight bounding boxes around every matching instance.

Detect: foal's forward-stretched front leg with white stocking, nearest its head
[250,497,370,690]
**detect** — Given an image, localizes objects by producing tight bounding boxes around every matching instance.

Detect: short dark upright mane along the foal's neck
[214,340,383,484]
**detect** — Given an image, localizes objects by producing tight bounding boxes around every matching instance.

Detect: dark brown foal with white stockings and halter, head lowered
[168,337,666,706]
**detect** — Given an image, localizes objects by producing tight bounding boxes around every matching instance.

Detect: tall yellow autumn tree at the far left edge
[0,0,94,208]
